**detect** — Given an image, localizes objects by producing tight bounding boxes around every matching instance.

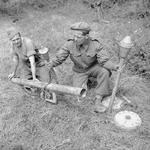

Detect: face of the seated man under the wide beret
[74,32,86,45]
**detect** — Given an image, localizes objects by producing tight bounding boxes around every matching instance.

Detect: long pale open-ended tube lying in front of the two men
[11,78,86,97]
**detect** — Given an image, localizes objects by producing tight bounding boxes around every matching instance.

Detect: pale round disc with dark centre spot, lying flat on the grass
[114,111,142,130]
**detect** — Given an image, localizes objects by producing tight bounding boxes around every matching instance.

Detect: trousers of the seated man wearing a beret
[73,65,110,96]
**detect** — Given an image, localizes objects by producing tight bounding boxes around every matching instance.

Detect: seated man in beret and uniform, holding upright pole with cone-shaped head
[42,22,118,112]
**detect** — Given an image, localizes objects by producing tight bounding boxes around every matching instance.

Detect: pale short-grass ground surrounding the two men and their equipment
[0,3,150,150]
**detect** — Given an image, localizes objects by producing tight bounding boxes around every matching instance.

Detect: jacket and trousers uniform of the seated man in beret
[49,38,114,96]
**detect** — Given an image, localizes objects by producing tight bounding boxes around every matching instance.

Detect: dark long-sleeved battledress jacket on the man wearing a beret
[50,38,114,73]
